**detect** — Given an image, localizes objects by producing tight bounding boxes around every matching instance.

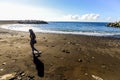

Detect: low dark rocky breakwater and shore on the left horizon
[0,20,48,24]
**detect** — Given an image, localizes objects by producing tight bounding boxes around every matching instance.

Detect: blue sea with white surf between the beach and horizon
[1,22,120,37]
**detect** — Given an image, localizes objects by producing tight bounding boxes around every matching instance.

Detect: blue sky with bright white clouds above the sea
[0,0,120,22]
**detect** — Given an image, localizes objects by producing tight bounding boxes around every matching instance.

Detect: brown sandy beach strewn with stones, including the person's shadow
[0,24,120,80]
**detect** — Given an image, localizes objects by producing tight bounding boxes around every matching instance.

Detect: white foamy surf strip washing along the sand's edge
[0,24,120,38]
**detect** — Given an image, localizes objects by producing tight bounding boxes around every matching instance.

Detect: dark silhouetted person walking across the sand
[29,29,39,53]
